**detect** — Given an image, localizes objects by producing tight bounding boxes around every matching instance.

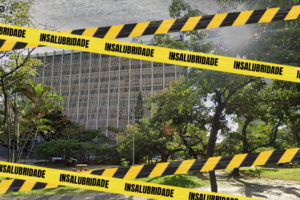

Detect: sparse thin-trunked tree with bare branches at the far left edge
[0,0,41,161]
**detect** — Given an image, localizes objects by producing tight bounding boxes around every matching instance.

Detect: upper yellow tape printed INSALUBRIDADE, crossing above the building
[0,24,300,82]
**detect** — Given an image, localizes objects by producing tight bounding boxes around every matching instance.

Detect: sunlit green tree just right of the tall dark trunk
[222,82,289,176]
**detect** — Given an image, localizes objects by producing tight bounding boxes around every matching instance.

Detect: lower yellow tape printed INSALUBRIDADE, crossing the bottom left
[0,161,260,200]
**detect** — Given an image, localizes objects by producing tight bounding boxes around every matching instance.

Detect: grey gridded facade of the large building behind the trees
[33,50,185,134]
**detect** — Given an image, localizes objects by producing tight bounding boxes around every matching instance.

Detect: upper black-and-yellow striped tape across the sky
[0,5,300,51]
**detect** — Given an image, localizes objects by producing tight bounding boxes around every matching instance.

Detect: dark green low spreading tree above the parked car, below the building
[35,129,115,163]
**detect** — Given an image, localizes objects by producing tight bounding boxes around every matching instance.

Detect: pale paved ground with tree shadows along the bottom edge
[0,178,300,200]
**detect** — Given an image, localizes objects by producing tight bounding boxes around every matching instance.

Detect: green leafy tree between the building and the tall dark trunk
[151,77,207,159]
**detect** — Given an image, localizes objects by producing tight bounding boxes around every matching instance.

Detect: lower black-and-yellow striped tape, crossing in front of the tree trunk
[0,148,300,194]
